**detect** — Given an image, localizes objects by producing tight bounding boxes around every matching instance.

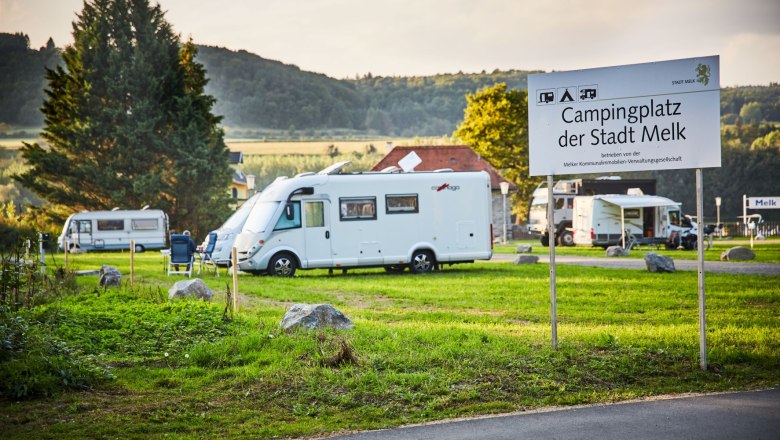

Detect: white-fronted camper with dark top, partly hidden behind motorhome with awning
[528,176,655,246]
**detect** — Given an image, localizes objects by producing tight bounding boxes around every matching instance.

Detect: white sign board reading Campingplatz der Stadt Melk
[528,56,720,176]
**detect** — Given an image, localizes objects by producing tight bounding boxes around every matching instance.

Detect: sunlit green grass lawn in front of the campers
[0,249,780,439]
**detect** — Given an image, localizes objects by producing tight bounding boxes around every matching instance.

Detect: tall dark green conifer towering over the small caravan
[16,0,231,237]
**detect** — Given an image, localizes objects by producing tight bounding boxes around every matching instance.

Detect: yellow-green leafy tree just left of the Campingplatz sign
[453,83,540,222]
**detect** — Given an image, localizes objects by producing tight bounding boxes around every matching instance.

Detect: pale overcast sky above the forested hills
[0,0,780,87]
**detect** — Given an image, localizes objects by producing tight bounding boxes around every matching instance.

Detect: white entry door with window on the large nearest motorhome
[303,200,333,267]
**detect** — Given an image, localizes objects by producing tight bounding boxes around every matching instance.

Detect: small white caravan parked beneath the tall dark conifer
[57,209,168,252]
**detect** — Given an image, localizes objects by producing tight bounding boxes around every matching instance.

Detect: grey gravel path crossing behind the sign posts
[490,254,780,276]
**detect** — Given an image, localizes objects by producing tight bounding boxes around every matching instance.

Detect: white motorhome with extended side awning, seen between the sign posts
[573,194,689,248]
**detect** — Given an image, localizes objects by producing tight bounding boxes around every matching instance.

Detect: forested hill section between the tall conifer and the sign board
[198,46,540,136]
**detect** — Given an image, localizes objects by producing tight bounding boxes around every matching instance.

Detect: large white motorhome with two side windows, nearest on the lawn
[236,163,493,276]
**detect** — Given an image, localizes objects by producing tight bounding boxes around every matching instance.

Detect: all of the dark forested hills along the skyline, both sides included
[0,33,780,138]
